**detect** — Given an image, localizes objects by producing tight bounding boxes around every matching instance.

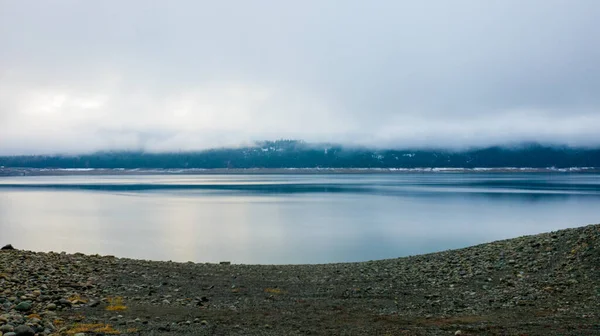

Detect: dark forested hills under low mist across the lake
[0,140,600,169]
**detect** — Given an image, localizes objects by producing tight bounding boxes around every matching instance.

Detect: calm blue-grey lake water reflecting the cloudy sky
[0,173,600,263]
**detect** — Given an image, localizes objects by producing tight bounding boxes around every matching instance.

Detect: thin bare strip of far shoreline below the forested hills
[0,167,600,176]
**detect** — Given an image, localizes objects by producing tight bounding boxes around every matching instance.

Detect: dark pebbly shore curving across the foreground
[0,225,600,336]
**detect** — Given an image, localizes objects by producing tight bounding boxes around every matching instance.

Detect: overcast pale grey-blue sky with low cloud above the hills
[0,0,600,155]
